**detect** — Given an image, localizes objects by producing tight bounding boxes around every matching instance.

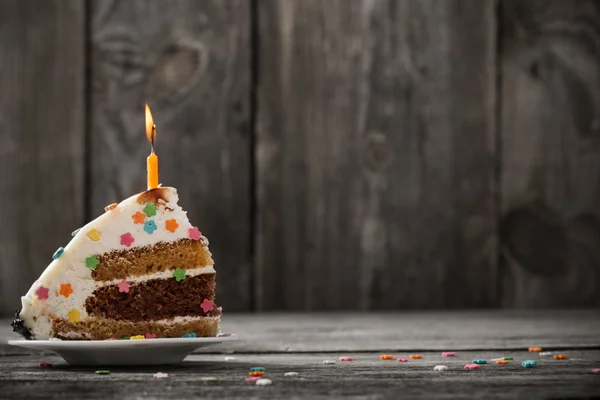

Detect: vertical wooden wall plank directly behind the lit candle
[91,0,251,311]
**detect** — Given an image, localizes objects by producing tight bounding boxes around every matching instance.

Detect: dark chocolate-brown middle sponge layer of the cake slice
[85,273,218,321]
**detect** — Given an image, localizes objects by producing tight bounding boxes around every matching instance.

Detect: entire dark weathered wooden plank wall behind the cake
[0,0,600,315]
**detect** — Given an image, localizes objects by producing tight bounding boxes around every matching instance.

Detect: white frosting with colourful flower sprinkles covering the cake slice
[20,187,214,339]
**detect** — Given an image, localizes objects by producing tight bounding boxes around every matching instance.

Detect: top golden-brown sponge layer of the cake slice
[92,239,213,281]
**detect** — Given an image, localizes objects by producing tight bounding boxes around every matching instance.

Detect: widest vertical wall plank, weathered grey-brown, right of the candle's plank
[256,0,498,310]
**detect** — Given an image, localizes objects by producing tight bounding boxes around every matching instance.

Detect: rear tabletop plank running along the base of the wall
[0,310,600,354]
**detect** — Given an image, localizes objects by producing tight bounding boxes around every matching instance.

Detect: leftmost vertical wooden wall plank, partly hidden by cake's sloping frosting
[0,0,85,315]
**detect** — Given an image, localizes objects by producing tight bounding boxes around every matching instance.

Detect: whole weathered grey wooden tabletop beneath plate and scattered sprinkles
[0,311,600,399]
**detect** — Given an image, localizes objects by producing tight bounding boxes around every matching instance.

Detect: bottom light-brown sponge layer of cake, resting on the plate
[52,310,220,340]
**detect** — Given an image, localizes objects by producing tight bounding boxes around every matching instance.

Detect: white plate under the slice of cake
[8,335,238,366]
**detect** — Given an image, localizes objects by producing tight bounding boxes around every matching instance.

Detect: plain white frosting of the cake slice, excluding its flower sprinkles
[20,187,215,339]
